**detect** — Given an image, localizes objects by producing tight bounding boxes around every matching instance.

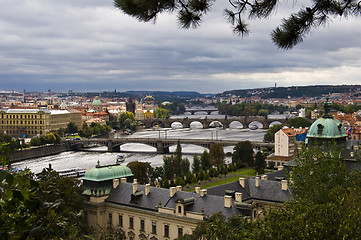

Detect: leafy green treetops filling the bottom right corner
[181,146,361,240]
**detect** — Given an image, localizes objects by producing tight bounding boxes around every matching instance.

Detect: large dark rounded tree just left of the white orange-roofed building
[232,141,254,167]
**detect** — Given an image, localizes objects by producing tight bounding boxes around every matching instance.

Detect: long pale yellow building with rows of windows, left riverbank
[0,108,81,137]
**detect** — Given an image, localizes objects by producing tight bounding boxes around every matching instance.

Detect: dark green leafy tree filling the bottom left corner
[0,168,88,239]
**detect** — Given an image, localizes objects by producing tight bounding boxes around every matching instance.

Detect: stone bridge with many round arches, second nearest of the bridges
[140,115,288,129]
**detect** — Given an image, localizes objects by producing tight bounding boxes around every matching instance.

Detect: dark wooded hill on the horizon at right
[219,85,361,98]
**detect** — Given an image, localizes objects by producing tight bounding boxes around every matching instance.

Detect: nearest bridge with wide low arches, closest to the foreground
[65,138,273,153]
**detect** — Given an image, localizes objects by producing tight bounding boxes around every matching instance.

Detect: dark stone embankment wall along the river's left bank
[9,144,70,162]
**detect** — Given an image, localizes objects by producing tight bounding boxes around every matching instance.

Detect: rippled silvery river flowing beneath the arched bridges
[13,128,266,173]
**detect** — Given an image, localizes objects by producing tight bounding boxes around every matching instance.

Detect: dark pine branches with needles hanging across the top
[114,0,360,49]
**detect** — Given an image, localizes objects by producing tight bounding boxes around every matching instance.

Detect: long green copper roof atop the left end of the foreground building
[83,164,133,182]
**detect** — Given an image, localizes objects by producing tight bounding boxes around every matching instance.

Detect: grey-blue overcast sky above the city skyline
[0,0,361,93]
